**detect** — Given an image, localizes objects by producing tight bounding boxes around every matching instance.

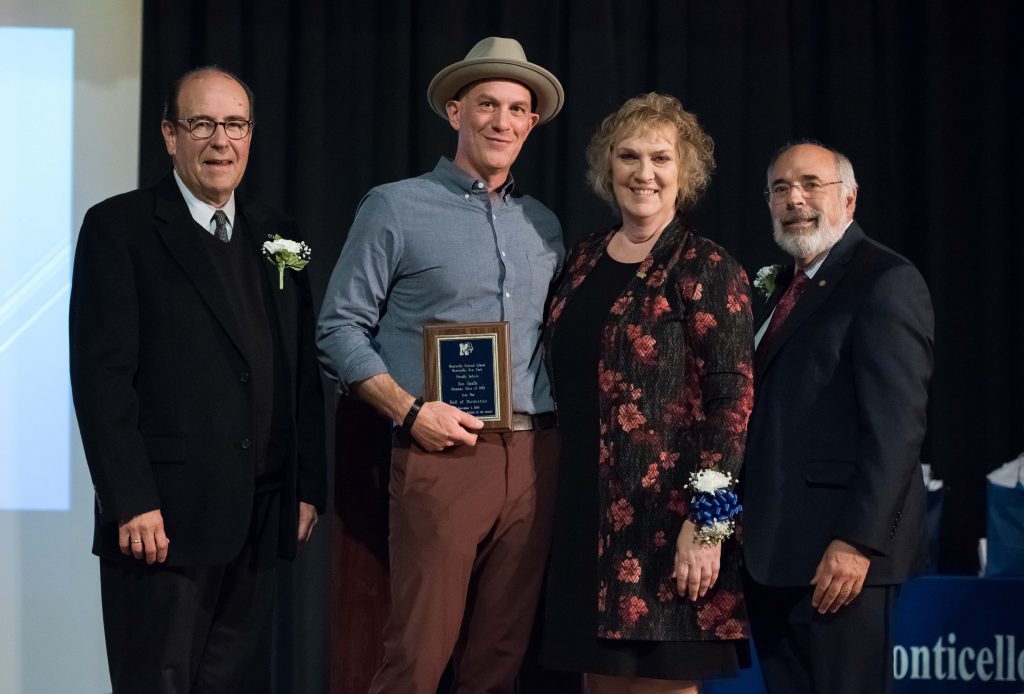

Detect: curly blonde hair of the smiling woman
[587,92,715,211]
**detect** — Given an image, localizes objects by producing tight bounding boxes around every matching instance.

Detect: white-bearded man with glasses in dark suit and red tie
[743,143,933,694]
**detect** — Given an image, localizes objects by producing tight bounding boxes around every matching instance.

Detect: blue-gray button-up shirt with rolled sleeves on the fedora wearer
[316,158,565,414]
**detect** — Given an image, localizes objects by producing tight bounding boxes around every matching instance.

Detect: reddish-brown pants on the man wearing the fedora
[370,429,558,694]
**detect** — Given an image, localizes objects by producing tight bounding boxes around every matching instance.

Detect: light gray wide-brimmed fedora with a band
[427,36,565,125]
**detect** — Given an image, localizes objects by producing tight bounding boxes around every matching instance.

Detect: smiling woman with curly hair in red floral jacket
[544,93,753,694]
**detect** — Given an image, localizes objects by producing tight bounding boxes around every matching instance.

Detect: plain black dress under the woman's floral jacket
[541,253,750,680]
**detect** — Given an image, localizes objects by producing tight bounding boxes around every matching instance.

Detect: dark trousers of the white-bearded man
[744,575,899,694]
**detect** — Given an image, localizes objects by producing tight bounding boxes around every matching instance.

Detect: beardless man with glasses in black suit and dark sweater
[71,68,326,694]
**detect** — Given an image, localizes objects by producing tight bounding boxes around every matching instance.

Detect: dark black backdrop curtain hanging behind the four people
[139,0,1024,691]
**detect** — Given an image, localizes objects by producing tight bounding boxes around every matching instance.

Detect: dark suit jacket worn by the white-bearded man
[743,222,934,587]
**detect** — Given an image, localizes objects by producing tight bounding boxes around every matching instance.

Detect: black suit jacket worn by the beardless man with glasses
[70,174,326,566]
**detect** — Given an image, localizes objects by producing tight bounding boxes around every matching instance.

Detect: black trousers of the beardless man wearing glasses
[99,491,281,694]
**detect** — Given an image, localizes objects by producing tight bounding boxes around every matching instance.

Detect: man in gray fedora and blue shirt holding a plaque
[317,37,564,694]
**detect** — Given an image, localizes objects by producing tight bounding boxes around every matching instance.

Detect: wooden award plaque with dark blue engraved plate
[423,320,512,431]
